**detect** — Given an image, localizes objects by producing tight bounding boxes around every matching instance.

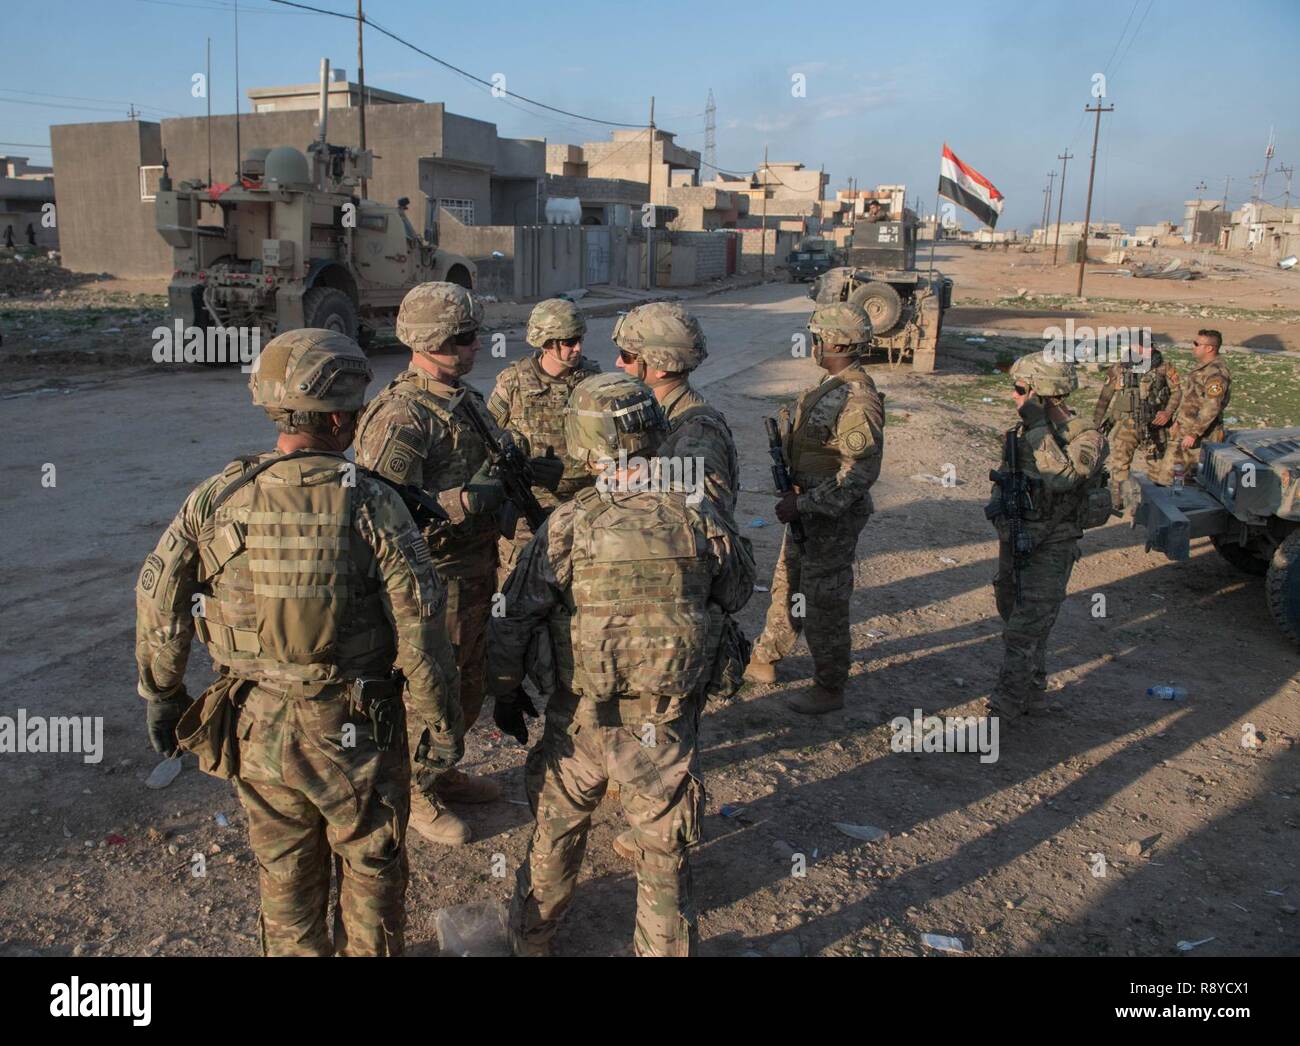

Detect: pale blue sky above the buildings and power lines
[0,0,1300,230]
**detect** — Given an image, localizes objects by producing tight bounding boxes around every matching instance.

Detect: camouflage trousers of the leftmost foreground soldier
[235,687,410,955]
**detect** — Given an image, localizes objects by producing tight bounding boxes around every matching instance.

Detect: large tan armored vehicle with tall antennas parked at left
[155,66,477,346]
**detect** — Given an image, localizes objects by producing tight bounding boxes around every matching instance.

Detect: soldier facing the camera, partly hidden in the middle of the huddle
[488,298,601,585]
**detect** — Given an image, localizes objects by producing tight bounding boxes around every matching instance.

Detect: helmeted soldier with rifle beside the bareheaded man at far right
[1092,348,1183,509]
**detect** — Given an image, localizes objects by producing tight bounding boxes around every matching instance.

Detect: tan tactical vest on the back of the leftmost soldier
[194,452,397,683]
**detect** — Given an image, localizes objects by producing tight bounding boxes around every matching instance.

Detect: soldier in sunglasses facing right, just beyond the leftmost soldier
[356,283,563,846]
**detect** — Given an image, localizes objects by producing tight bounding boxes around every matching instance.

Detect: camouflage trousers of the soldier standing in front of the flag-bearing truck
[754,507,871,691]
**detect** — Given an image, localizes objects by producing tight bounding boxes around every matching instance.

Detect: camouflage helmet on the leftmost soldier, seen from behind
[248,327,373,431]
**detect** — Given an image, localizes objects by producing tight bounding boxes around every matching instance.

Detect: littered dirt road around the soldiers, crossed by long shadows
[0,285,1300,955]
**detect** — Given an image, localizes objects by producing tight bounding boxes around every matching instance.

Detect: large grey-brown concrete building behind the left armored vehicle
[51,82,546,277]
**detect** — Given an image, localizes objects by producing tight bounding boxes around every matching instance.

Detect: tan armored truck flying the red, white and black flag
[809,209,953,373]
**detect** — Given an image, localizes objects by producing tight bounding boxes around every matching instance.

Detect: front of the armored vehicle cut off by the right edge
[1125,429,1300,644]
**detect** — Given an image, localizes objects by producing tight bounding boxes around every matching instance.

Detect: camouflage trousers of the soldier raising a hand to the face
[993,538,1079,715]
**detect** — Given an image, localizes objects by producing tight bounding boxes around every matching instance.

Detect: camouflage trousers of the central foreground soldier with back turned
[510,708,705,955]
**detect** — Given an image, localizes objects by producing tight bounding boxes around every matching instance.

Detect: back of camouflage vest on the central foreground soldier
[553,489,723,702]
